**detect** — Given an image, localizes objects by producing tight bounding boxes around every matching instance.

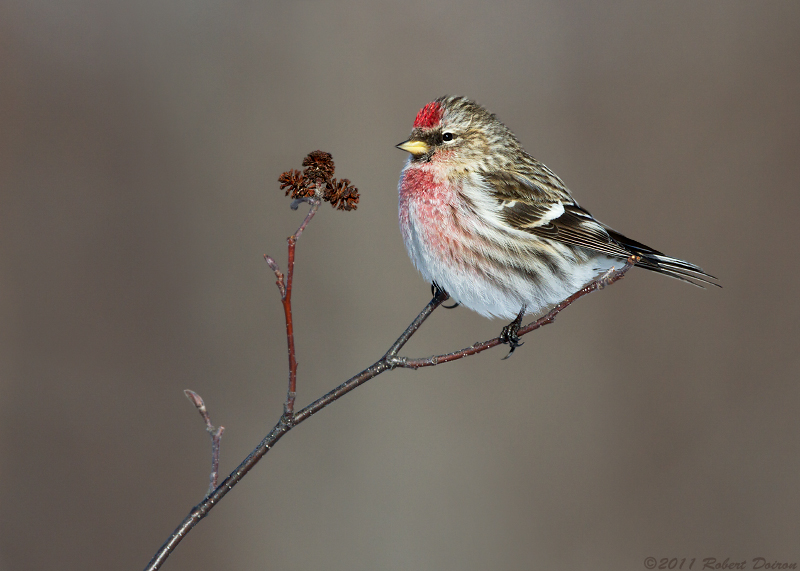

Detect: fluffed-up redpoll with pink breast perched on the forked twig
[396,96,720,356]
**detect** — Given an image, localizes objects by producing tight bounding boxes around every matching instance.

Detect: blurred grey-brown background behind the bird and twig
[0,0,800,571]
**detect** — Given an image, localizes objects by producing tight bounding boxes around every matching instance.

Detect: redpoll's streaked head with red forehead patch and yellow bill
[397,96,524,168]
